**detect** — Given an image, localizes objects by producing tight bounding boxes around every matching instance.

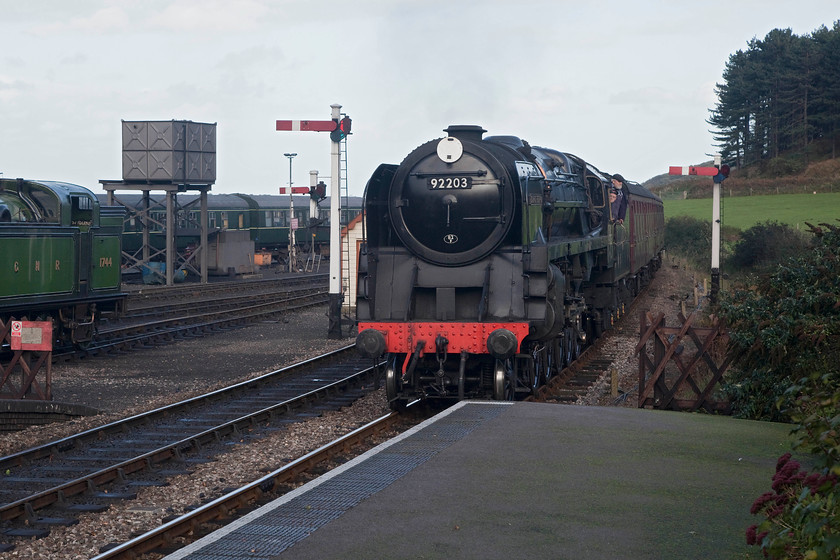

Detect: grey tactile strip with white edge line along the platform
[163,401,513,560]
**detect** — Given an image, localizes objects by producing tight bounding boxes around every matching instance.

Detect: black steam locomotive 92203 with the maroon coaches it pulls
[356,125,664,408]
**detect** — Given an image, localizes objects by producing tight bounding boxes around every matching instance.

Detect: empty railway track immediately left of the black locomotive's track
[0,347,376,552]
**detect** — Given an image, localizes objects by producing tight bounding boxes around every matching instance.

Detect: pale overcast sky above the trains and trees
[0,0,840,195]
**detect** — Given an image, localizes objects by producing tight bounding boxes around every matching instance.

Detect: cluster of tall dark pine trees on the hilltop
[707,20,840,167]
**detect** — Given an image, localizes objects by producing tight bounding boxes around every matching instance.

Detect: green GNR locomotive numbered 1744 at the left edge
[0,179,125,345]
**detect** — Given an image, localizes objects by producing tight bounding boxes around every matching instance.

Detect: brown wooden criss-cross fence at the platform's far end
[636,312,731,414]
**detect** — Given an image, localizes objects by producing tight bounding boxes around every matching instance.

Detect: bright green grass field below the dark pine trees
[664,193,840,230]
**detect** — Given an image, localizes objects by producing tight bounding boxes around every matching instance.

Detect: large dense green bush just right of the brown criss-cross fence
[720,225,840,421]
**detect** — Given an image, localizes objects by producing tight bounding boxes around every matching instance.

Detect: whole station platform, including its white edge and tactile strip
[165,402,790,560]
